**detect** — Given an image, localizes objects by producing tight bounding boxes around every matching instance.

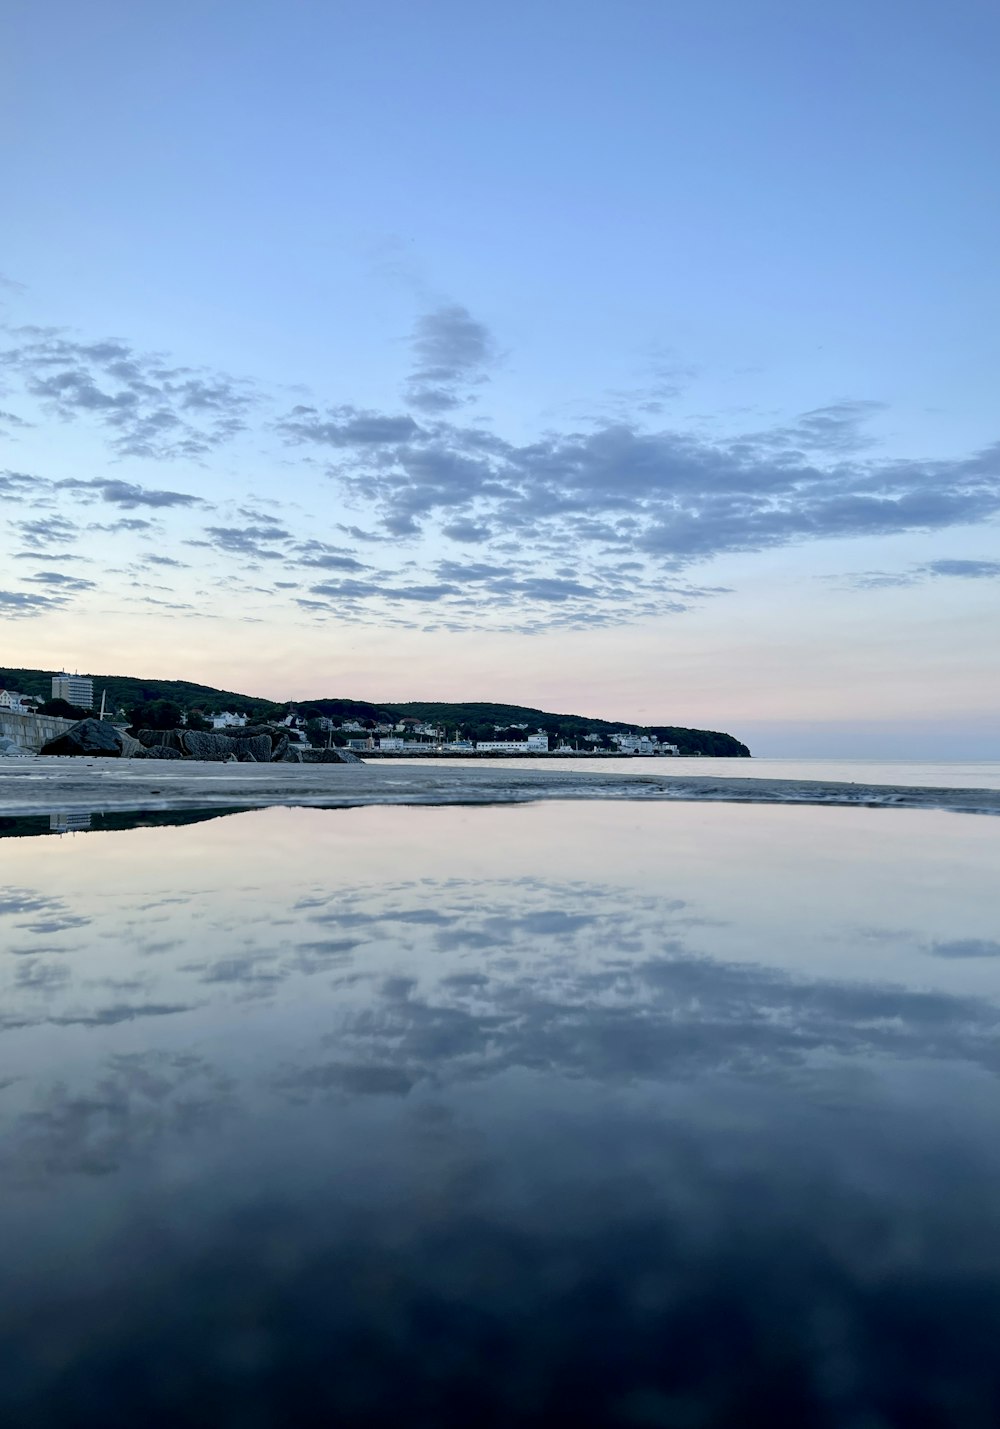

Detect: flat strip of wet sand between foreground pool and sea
[0,756,1000,817]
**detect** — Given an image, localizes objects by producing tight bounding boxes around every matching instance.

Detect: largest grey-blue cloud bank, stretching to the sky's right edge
[325,424,1000,588]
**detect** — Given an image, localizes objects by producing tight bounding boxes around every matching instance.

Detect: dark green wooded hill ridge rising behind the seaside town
[0,669,750,759]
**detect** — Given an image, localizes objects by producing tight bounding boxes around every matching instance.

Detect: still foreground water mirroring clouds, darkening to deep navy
[0,803,1000,1429]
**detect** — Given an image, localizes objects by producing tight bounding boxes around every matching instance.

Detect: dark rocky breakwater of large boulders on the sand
[41,719,361,765]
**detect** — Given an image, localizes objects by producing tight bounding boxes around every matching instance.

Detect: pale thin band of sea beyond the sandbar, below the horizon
[380,755,1000,789]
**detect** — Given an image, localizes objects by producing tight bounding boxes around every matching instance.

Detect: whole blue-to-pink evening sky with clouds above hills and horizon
[0,0,1000,759]
